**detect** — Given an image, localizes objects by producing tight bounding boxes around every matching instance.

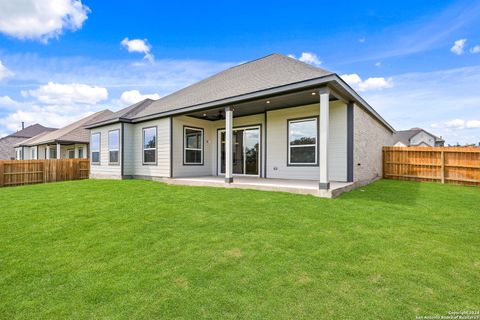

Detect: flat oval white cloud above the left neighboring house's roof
[22,82,108,105]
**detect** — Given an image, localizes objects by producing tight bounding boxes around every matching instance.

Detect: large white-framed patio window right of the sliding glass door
[288,118,318,165]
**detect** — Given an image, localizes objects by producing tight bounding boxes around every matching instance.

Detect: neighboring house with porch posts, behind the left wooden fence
[15,110,113,160]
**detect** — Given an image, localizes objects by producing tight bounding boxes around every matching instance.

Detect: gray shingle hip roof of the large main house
[88,54,394,131]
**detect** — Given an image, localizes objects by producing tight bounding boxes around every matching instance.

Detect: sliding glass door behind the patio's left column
[218,127,260,176]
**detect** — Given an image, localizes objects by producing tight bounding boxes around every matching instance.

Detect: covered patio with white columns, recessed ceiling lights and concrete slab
[168,80,353,198]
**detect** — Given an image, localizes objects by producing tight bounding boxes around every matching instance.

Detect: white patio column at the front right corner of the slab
[318,88,330,190]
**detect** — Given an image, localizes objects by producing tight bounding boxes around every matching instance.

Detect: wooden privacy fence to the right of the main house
[383,147,480,186]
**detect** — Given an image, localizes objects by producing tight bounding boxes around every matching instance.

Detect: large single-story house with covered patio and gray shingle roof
[87,54,394,196]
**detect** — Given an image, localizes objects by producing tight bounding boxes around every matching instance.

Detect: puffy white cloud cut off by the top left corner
[0,0,90,42]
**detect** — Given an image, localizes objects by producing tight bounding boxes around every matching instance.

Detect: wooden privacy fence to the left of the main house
[0,159,90,187]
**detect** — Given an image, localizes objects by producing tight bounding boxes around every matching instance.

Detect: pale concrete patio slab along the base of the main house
[166,176,354,198]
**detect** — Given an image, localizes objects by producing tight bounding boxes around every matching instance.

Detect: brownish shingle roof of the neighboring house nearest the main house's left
[17,110,113,146]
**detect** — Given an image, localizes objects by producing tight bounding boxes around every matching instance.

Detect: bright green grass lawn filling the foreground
[0,180,480,319]
